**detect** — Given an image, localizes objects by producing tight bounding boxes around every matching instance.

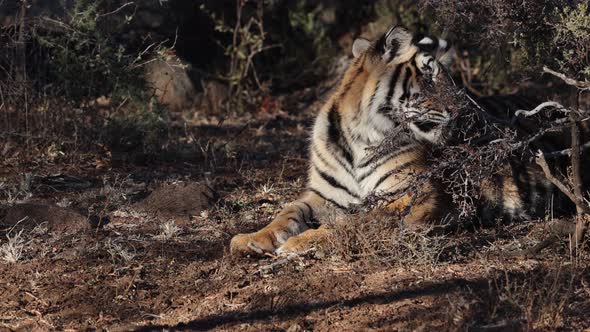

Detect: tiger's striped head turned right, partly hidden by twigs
[352,26,454,144]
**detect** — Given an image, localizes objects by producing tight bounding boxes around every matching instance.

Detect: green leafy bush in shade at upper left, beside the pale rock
[32,0,144,100]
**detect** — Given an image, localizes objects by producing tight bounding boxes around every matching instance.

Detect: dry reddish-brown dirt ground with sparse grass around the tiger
[0,94,590,331]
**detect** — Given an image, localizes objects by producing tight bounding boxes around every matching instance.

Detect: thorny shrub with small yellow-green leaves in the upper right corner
[420,0,590,93]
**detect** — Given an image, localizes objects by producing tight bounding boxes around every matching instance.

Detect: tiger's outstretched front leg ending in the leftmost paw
[230,192,326,255]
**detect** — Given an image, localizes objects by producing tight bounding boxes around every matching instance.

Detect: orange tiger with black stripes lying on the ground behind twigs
[230,26,588,255]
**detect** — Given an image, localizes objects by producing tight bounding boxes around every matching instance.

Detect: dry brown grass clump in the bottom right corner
[471,261,590,331]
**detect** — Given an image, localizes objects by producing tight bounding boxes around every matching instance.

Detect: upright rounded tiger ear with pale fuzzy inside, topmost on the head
[377,26,417,62]
